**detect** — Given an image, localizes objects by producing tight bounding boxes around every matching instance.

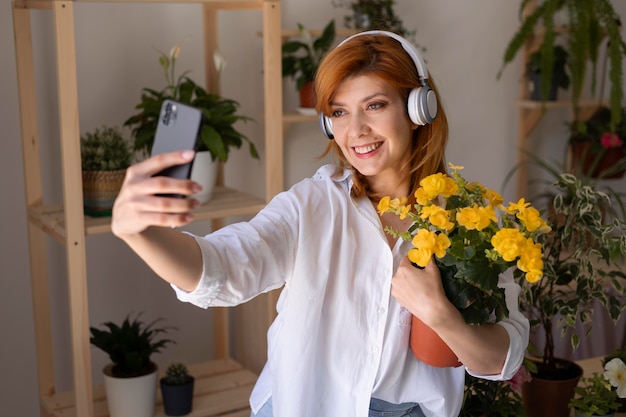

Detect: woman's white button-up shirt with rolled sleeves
[175,165,528,417]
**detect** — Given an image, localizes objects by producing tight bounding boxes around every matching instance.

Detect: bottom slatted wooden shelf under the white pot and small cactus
[41,358,258,417]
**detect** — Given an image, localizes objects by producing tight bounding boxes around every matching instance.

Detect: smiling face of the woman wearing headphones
[330,74,417,195]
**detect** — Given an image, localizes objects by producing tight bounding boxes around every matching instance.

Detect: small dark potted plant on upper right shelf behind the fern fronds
[526,45,570,101]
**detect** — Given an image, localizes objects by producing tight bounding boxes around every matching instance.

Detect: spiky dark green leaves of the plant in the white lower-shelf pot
[89,314,176,378]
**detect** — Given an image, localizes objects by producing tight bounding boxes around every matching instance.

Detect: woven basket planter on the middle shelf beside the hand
[83,169,126,216]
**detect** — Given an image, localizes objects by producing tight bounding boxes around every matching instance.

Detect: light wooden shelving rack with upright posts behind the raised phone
[12,0,284,417]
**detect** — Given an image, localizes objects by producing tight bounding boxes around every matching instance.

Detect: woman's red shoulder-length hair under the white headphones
[315,35,448,199]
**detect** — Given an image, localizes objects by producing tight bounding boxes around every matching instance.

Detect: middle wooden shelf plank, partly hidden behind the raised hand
[28,187,266,239]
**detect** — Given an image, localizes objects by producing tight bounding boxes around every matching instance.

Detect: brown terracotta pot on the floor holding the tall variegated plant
[522,359,583,417]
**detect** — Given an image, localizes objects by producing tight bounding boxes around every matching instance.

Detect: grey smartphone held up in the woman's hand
[152,100,202,179]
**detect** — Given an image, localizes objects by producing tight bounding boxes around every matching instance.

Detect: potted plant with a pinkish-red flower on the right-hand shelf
[569,106,626,179]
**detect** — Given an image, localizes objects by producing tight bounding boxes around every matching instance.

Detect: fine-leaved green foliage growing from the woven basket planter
[80,126,134,171]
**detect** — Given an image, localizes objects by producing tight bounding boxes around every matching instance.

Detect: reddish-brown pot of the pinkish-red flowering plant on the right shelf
[571,142,626,179]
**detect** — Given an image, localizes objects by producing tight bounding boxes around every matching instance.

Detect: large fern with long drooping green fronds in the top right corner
[498,0,626,130]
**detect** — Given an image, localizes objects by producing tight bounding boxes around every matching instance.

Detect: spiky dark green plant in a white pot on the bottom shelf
[89,315,175,417]
